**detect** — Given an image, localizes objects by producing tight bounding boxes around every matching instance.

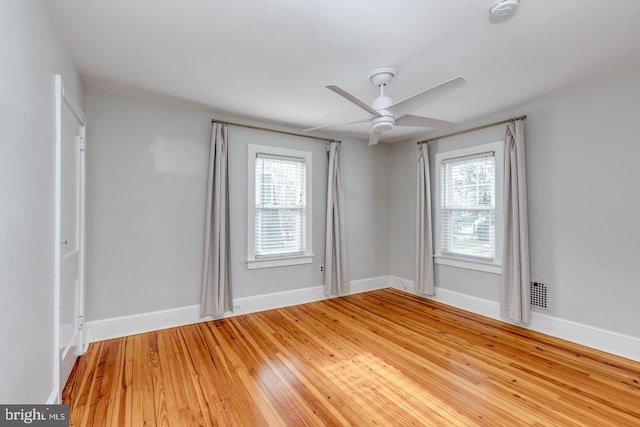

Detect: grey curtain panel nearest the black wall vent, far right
[500,120,531,323]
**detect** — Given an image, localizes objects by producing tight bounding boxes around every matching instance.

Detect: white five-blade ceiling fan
[305,67,467,145]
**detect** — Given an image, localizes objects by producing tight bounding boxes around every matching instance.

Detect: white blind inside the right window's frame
[439,151,496,262]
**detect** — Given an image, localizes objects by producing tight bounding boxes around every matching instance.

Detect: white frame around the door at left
[53,74,87,403]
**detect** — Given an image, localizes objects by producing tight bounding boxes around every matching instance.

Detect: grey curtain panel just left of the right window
[415,144,436,295]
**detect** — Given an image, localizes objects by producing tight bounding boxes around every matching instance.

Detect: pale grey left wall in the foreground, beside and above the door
[0,0,85,403]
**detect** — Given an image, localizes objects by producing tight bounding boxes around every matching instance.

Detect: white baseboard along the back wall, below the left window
[85,276,389,343]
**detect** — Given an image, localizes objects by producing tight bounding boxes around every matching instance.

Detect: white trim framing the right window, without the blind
[433,141,504,274]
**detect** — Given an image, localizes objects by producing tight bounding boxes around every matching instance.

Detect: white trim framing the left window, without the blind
[247,144,313,270]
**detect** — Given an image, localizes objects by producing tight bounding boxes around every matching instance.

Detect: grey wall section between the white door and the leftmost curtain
[86,90,211,320]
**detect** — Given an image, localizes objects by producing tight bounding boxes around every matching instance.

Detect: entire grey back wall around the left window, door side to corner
[82,90,390,321]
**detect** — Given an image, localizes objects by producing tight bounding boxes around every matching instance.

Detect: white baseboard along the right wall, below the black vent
[390,276,640,362]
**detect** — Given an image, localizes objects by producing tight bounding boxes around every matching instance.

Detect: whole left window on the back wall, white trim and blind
[247,145,312,269]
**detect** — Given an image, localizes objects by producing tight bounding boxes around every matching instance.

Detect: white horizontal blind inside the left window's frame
[255,153,307,259]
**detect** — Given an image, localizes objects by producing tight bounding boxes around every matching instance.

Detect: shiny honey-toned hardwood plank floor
[63,289,640,427]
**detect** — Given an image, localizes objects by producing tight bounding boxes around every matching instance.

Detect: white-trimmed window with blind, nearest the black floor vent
[435,142,504,273]
